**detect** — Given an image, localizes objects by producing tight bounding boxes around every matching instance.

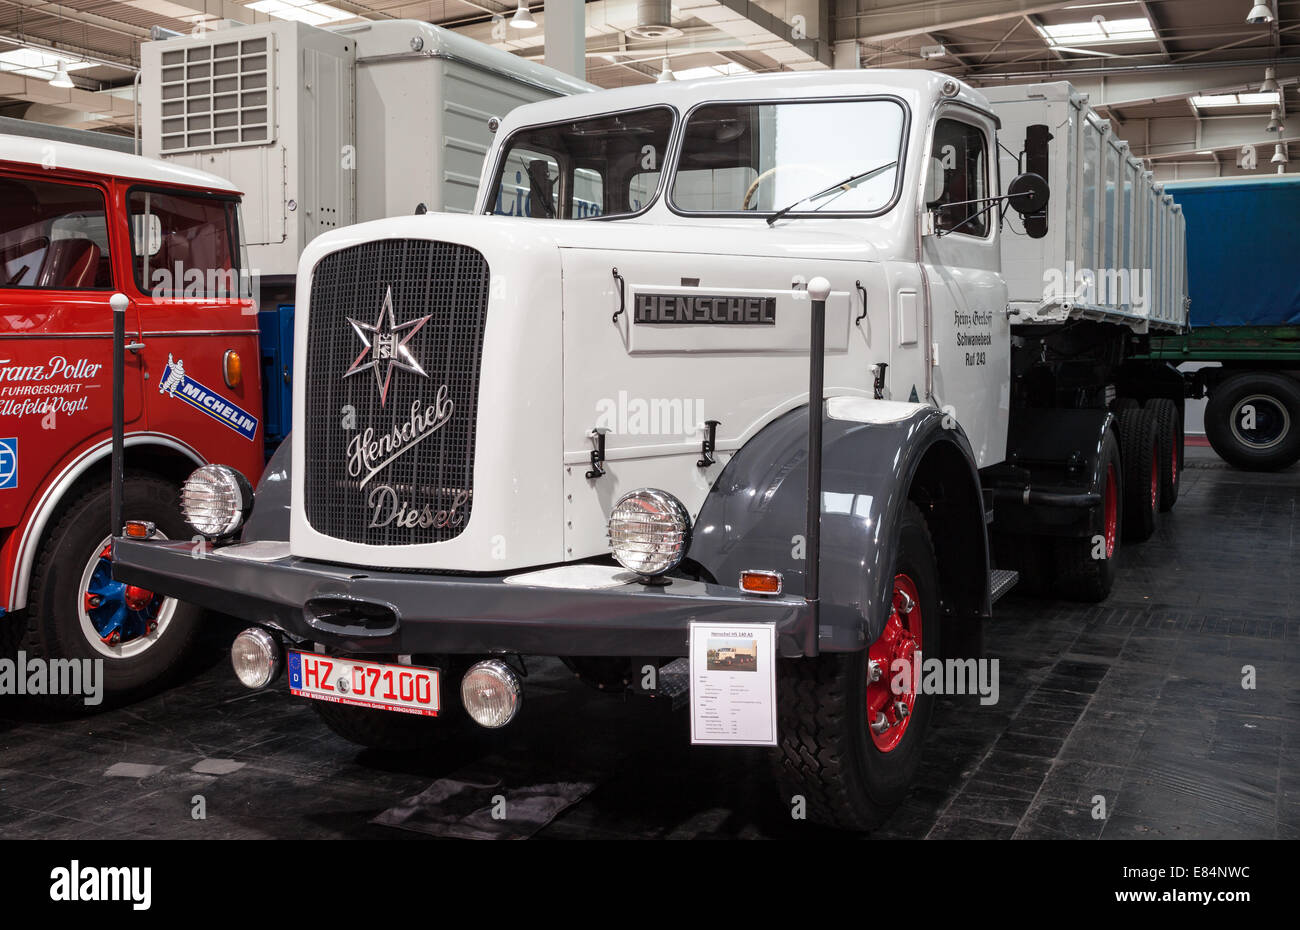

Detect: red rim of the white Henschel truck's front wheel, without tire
[867,575,922,752]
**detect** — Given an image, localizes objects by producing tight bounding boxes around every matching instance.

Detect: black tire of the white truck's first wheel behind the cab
[1052,429,1125,604]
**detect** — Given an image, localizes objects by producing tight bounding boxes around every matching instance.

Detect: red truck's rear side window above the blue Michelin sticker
[127,190,241,299]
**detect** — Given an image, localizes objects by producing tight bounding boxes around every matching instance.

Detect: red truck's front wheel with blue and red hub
[21,473,200,702]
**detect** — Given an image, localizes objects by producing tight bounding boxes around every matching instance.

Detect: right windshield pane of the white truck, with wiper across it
[672,100,906,215]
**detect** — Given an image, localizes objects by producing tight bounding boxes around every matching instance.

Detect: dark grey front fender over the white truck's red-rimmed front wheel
[689,398,989,656]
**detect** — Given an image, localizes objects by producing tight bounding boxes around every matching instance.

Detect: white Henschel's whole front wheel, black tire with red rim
[772,503,944,830]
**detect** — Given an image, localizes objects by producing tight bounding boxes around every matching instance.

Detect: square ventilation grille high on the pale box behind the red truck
[161,36,276,152]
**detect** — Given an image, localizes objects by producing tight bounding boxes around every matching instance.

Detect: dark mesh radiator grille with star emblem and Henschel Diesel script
[299,239,489,546]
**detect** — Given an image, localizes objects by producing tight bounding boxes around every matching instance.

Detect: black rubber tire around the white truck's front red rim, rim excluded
[772,503,944,830]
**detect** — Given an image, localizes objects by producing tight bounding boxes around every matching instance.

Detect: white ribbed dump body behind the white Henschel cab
[982,82,1187,333]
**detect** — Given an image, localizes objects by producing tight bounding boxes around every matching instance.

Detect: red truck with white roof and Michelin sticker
[0,134,265,697]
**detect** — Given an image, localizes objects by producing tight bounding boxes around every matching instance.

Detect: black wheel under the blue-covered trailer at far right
[1205,372,1300,471]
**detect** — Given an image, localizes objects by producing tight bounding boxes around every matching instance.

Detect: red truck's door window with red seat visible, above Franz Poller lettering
[0,178,113,290]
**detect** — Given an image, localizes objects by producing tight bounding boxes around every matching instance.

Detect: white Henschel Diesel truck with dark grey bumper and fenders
[114,70,1186,829]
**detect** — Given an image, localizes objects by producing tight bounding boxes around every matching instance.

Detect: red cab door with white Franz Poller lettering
[0,168,143,525]
